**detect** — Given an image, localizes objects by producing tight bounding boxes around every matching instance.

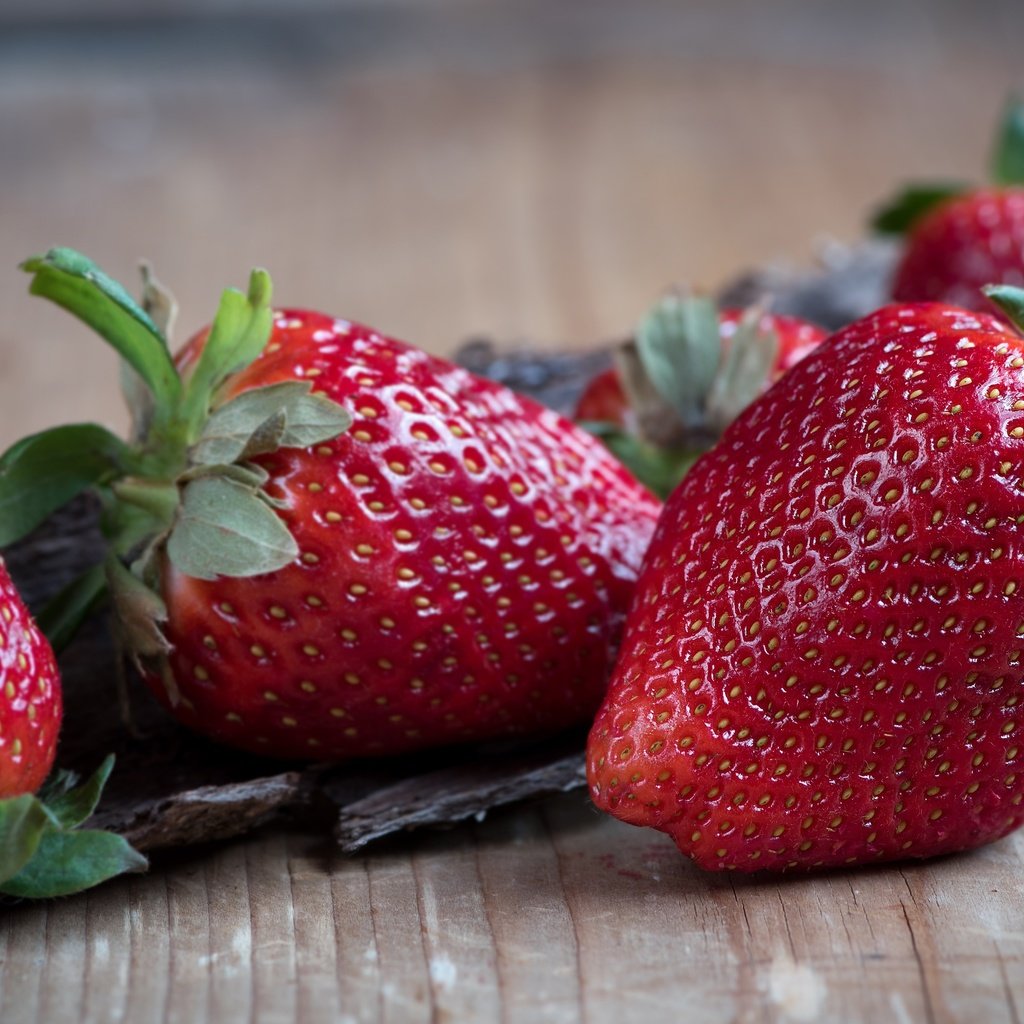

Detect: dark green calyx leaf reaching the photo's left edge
[0,423,133,547]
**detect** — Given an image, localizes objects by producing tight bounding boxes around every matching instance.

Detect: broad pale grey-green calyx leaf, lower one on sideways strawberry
[167,476,299,580]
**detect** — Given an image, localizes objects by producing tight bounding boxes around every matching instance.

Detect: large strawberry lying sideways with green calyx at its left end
[0,250,659,758]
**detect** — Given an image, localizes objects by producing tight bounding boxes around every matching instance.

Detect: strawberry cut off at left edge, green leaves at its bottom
[0,559,146,898]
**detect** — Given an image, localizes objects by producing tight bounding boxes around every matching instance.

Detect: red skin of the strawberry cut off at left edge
[0,560,62,799]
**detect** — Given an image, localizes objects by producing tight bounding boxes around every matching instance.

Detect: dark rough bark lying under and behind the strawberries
[4,239,892,850]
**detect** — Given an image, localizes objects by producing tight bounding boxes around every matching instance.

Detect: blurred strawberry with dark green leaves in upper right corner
[873,97,1024,312]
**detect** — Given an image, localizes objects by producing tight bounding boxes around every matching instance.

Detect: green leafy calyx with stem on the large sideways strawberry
[0,249,350,656]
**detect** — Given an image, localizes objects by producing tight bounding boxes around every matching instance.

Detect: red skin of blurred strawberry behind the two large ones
[572,309,828,430]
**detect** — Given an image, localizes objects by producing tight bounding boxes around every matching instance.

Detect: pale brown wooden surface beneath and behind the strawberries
[0,0,1024,1024]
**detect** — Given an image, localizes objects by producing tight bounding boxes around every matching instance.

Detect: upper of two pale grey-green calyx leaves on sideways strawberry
[191,381,352,465]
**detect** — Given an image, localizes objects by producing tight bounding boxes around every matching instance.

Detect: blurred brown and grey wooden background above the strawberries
[0,0,1024,446]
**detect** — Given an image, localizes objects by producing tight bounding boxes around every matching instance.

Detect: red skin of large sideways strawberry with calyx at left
[150,310,659,758]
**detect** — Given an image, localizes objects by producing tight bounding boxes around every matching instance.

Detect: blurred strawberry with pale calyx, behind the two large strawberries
[573,294,827,498]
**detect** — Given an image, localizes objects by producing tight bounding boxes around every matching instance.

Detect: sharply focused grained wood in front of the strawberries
[0,794,1024,1024]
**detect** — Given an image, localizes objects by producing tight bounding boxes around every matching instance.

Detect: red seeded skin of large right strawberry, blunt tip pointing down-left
[588,304,1024,871]
